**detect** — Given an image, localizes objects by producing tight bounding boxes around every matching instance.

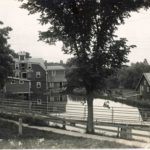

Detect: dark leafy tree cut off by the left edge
[0,21,15,89]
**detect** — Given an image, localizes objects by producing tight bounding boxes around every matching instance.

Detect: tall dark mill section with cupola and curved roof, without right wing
[6,52,46,105]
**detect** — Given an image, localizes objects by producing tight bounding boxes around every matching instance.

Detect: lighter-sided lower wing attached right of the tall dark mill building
[46,65,67,112]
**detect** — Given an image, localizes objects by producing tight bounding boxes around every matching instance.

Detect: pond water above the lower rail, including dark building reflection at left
[49,95,149,124]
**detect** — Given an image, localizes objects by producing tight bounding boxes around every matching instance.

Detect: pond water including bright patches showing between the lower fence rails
[47,95,149,141]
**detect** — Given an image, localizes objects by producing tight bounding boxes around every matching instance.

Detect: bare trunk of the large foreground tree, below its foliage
[87,94,94,133]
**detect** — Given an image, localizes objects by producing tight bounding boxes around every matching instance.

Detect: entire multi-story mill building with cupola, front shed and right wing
[5,52,67,111]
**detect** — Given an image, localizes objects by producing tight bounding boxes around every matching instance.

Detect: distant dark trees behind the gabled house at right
[106,62,150,89]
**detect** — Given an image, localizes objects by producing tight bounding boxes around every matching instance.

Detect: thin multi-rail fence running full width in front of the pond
[0,99,150,125]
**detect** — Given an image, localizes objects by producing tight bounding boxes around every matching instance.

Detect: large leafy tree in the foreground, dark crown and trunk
[18,0,150,132]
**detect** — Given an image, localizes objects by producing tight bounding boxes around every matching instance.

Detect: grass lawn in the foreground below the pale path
[0,120,136,149]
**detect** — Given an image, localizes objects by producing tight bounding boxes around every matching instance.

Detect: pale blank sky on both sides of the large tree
[0,0,150,63]
